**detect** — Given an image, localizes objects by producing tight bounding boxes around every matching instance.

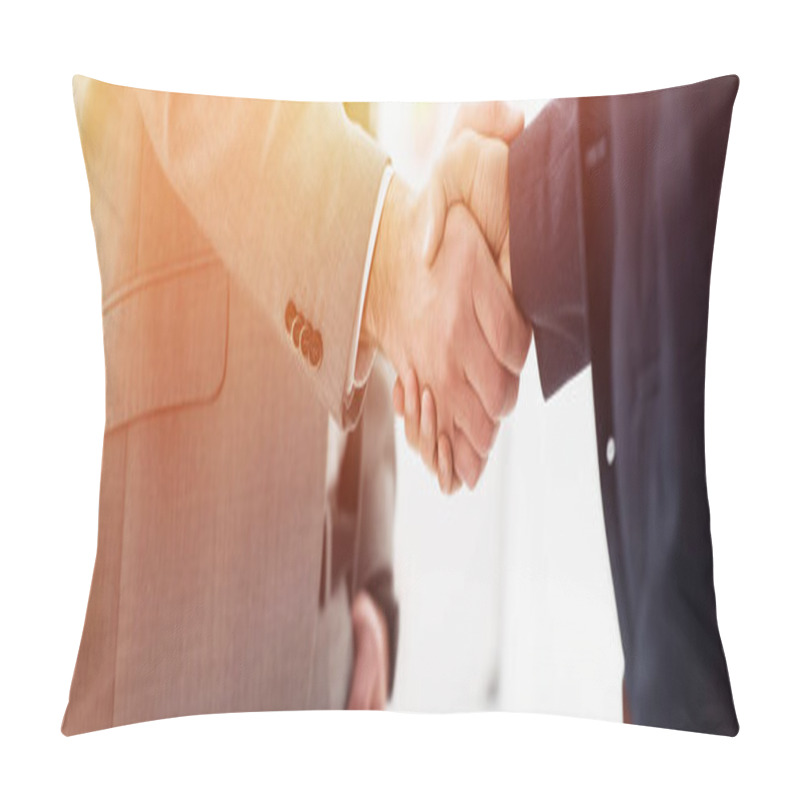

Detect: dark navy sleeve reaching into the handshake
[508,100,589,399]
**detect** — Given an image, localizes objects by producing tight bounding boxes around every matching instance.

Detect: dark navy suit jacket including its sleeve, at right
[509,76,739,735]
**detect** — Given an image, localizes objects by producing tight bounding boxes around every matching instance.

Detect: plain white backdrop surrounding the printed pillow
[0,0,800,797]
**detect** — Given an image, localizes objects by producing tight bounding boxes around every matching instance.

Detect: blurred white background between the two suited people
[377,101,623,720]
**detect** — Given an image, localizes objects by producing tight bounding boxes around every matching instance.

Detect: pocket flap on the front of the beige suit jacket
[103,260,228,430]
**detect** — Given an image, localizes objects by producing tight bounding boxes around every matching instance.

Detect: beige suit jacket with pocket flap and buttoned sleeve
[63,77,394,734]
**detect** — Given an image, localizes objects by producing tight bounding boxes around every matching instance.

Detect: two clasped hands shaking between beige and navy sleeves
[362,103,531,493]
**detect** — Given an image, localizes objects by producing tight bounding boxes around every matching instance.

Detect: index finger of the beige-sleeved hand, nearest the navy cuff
[472,241,531,375]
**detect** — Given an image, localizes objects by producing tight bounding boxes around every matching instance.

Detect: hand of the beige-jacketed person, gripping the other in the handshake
[365,193,530,488]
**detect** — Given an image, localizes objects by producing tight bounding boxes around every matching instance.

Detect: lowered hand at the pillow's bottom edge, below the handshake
[347,589,389,711]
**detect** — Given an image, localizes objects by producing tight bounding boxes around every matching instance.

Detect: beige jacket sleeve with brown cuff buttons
[137,84,387,428]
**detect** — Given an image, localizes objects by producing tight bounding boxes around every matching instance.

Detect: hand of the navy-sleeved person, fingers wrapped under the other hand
[393,103,523,493]
